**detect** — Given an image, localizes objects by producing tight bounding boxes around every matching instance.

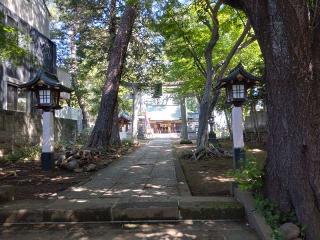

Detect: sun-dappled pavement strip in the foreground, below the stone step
[0,221,258,240]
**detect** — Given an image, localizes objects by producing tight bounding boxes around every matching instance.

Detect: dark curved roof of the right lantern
[216,63,261,89]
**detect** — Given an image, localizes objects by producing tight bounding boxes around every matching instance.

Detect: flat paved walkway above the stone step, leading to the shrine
[59,139,184,199]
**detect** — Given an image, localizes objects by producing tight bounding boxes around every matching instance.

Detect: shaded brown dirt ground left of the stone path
[0,143,141,200]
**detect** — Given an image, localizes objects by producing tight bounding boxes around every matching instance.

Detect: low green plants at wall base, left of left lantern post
[3,146,41,162]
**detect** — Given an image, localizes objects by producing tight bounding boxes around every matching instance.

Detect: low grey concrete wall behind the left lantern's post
[0,110,77,156]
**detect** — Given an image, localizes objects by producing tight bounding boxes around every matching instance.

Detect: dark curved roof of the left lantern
[19,69,72,93]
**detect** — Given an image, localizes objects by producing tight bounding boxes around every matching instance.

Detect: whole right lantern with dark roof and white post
[217,64,259,169]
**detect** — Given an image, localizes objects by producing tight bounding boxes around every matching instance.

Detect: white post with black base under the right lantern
[232,106,245,169]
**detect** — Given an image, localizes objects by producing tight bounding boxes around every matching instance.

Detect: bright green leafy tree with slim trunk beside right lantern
[155,0,254,159]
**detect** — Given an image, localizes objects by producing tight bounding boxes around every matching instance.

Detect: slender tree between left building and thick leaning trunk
[52,0,108,128]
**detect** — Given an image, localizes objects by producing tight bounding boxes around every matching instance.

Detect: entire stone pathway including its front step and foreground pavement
[0,139,258,240]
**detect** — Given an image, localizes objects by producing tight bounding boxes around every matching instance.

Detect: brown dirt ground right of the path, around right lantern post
[174,141,266,196]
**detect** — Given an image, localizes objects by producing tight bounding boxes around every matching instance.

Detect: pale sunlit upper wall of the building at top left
[0,0,50,38]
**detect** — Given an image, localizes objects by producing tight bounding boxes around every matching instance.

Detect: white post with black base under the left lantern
[41,111,54,171]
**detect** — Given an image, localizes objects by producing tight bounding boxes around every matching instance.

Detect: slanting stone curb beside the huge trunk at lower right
[234,188,272,240]
